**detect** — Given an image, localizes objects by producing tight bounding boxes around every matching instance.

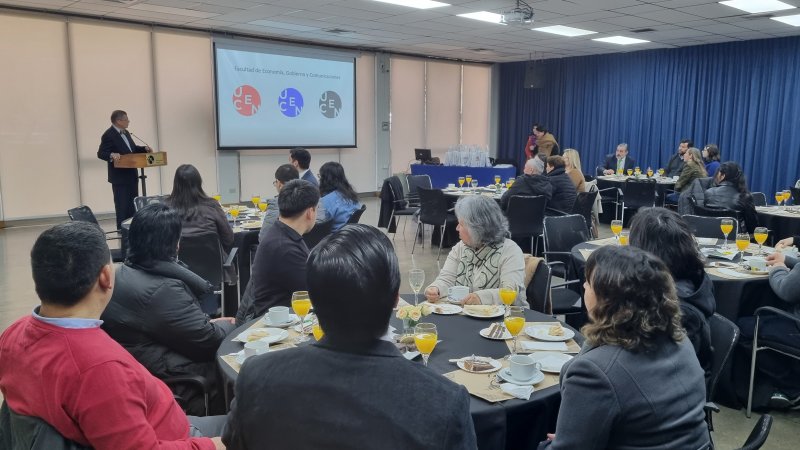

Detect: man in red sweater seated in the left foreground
[0,222,223,450]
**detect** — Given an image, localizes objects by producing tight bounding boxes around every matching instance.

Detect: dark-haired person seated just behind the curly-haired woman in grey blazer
[630,208,717,371]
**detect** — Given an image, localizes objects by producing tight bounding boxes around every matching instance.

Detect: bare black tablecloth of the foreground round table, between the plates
[217,295,583,449]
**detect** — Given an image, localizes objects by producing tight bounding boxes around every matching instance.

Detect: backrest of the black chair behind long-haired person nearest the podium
[178,231,225,290]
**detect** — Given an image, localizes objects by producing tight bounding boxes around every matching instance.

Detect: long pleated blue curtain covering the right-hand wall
[498,37,800,198]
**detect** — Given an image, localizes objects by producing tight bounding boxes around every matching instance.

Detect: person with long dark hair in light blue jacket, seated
[319,161,361,231]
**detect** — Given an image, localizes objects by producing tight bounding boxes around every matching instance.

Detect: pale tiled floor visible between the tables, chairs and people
[0,198,800,450]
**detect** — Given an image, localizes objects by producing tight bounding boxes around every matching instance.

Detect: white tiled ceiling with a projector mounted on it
[0,0,800,62]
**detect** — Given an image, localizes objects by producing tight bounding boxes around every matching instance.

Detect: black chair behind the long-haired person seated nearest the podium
[178,231,239,317]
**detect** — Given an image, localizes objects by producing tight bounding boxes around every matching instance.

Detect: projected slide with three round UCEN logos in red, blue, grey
[214,42,356,150]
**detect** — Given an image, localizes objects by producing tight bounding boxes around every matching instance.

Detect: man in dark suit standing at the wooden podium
[97,110,153,229]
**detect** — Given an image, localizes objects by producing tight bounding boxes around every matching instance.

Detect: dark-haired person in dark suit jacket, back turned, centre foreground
[223,224,477,450]
